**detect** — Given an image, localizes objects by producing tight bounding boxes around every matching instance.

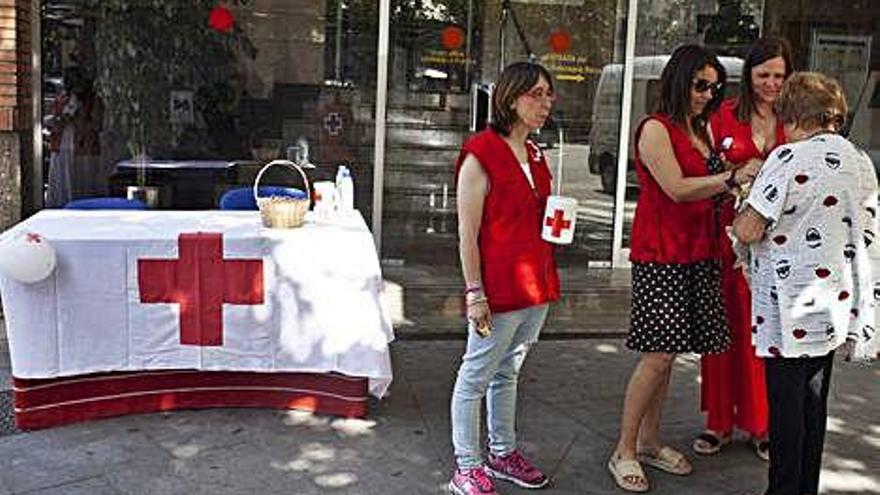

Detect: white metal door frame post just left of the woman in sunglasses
[611,0,639,268]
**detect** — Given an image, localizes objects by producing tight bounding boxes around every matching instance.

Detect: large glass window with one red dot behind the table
[41,0,378,217]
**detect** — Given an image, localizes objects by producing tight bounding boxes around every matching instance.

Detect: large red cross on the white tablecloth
[137,232,264,347]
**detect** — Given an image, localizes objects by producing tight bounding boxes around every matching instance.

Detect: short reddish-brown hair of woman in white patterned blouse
[775,72,848,130]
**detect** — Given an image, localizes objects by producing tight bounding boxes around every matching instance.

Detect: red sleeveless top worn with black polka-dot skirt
[629,114,718,264]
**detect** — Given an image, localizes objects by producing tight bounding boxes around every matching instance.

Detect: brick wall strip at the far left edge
[0,0,33,230]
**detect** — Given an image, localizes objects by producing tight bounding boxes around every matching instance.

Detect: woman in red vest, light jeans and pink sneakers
[449,62,559,495]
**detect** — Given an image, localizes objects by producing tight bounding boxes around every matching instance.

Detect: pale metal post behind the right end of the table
[373,0,391,254]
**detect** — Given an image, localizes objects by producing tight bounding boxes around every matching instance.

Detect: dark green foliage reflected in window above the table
[84,0,255,155]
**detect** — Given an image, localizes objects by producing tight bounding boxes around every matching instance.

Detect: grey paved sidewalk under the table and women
[0,322,880,495]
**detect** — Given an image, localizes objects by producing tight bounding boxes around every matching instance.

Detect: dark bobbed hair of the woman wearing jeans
[492,62,553,136]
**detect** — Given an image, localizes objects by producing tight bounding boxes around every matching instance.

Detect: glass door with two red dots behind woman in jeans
[382,0,626,287]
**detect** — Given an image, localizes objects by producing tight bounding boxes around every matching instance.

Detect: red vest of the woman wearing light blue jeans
[455,129,559,313]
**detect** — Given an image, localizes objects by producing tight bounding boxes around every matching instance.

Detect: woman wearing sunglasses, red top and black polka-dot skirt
[608,45,757,492]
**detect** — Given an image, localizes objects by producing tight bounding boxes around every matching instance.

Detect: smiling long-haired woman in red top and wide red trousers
[693,37,793,460]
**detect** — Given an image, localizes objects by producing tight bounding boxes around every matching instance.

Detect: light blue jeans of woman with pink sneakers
[451,304,549,469]
